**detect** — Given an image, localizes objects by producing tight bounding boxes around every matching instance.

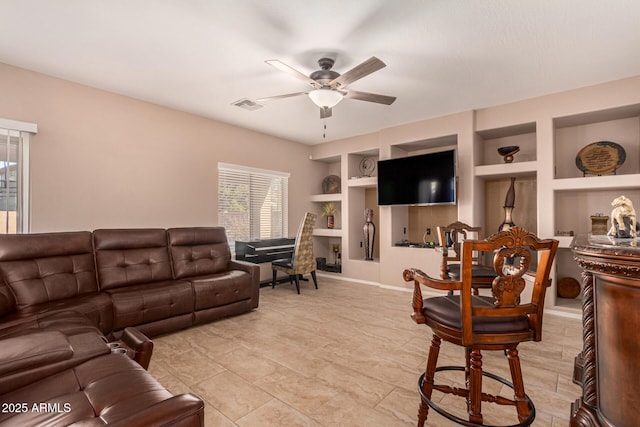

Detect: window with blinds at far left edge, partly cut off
[0,119,37,234]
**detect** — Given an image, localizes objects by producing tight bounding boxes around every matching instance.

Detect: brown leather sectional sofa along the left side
[0,227,260,426]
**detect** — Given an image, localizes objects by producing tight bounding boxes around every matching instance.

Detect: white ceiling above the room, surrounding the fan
[0,0,640,144]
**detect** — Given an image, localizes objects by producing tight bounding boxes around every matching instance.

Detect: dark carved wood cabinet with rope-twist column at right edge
[571,235,640,427]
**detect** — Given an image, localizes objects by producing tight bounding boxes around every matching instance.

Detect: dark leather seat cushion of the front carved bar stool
[422,295,530,334]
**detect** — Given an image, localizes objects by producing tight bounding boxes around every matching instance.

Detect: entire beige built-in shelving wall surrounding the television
[311,77,640,315]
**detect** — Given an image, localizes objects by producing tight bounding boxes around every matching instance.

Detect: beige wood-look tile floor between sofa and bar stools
[149,277,582,427]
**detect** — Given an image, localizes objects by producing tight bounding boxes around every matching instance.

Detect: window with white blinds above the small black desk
[218,163,289,250]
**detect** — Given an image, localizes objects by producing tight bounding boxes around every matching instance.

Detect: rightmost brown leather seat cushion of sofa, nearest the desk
[191,270,253,310]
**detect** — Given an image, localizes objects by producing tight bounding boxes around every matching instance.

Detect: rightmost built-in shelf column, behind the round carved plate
[547,104,640,308]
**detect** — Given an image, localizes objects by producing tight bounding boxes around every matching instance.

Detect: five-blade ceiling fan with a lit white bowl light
[256,56,396,119]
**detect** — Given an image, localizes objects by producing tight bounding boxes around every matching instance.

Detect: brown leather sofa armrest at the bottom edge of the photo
[108,393,204,427]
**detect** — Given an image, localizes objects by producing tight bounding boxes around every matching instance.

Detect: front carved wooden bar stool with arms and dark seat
[403,227,558,427]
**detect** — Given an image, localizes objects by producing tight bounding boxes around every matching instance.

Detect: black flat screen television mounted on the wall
[378,150,456,206]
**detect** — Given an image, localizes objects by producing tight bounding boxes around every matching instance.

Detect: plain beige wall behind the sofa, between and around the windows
[0,64,325,235]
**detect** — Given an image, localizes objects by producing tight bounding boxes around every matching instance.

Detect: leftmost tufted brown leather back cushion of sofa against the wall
[0,231,98,314]
